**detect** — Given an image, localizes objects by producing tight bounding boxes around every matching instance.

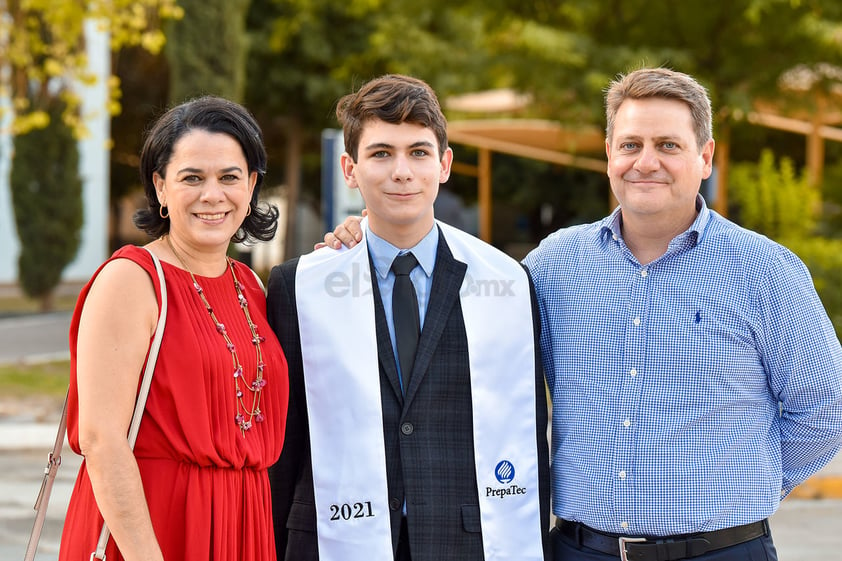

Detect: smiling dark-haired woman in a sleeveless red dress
[59,97,288,561]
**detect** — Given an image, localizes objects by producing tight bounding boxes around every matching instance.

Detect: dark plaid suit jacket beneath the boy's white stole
[268,232,550,561]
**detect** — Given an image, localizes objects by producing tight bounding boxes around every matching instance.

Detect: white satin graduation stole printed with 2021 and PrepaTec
[295,222,543,561]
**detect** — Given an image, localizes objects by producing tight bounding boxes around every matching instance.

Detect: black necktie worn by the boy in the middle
[392,253,421,391]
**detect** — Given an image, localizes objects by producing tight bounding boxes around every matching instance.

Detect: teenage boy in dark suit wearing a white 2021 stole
[268,75,549,561]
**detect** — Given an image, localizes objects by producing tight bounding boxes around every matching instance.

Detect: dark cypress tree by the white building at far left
[11,102,83,310]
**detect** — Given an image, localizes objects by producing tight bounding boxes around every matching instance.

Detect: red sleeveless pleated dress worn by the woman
[59,246,289,561]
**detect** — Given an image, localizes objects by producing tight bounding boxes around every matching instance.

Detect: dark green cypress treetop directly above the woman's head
[164,0,250,104]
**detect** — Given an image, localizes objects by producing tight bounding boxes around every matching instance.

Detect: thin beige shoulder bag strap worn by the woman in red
[23,248,167,561]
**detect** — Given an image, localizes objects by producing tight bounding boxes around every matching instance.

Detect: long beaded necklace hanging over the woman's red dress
[167,236,266,436]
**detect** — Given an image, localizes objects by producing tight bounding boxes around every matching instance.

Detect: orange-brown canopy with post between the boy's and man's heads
[447,119,606,243]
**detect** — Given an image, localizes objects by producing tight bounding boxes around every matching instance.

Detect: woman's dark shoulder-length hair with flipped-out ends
[134,96,278,242]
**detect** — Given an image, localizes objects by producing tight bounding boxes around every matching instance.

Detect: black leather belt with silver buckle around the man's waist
[556,519,769,561]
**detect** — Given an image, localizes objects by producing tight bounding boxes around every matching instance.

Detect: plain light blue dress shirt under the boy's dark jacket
[366,224,439,384]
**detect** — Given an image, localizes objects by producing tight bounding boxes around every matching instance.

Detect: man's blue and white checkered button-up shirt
[524,197,842,536]
